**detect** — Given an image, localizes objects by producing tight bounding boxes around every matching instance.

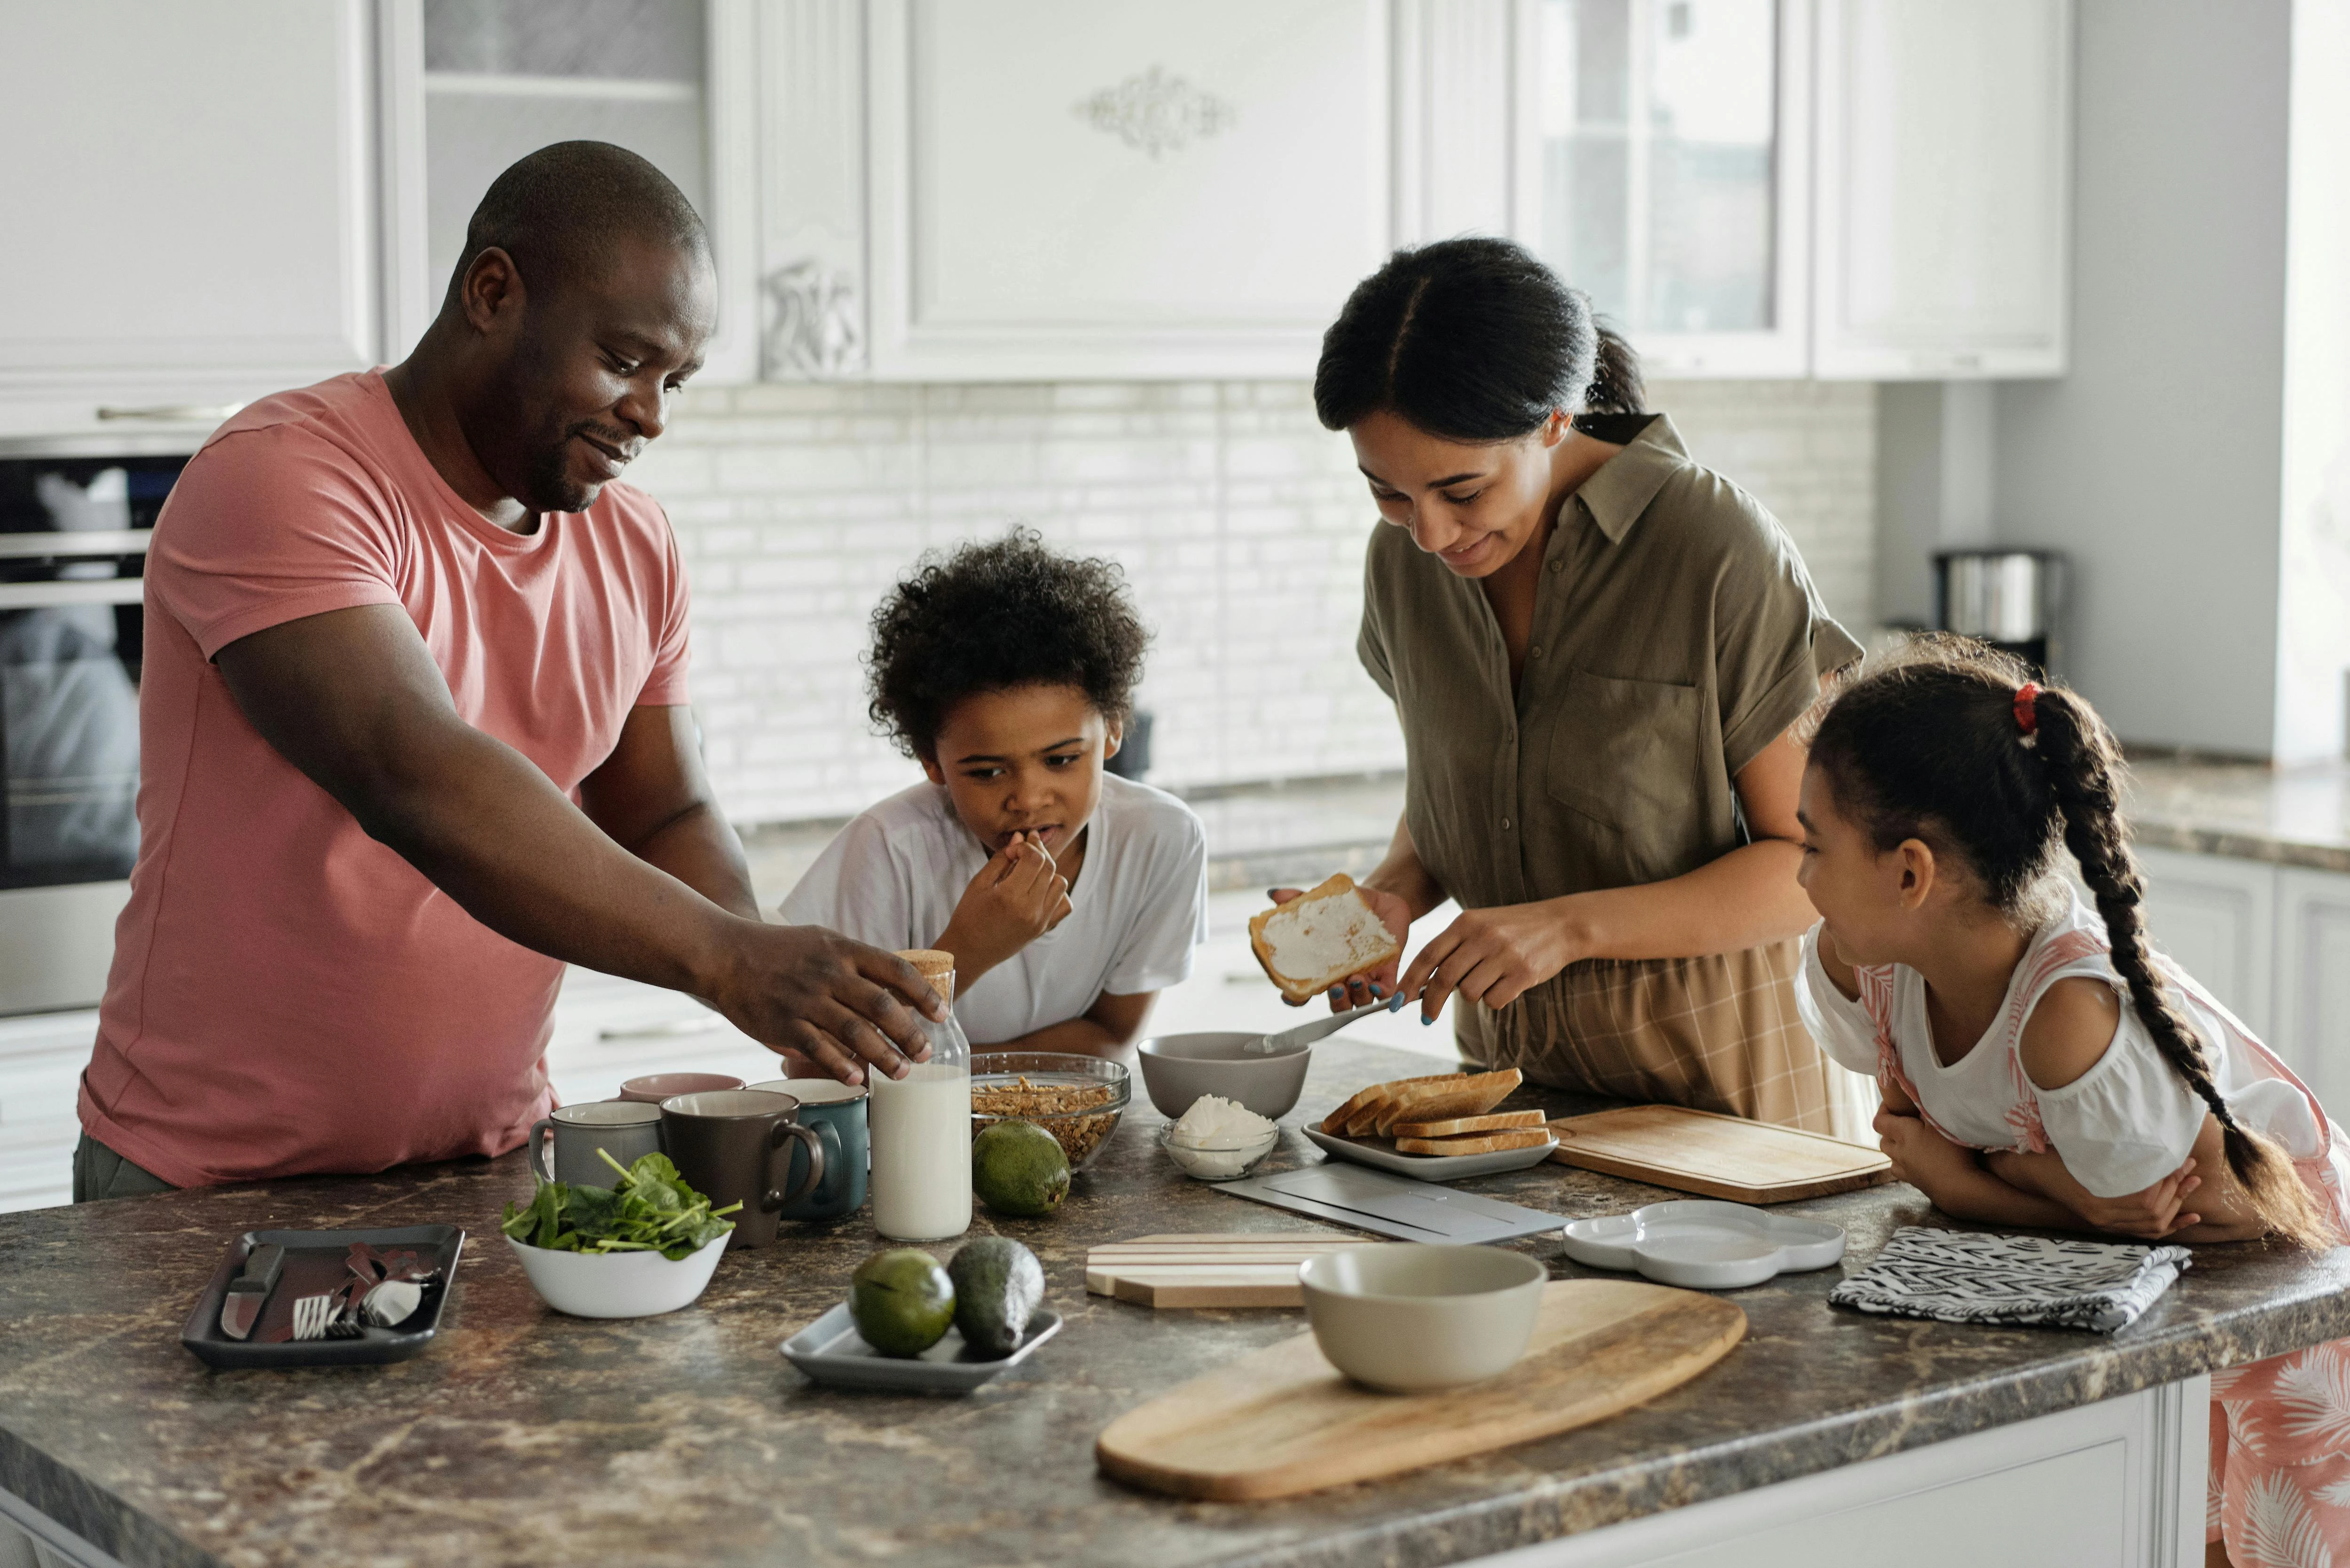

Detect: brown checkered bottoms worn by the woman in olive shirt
[1455,940,1852,1135]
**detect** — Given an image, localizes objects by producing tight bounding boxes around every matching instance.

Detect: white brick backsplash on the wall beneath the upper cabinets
[632,381,1875,823]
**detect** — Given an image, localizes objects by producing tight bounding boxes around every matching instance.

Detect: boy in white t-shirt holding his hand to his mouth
[783,529,1208,1055]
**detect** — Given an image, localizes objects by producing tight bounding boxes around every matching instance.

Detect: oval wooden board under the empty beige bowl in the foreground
[1093,1279,1746,1502]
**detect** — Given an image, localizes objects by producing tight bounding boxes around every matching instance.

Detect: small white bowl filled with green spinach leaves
[498,1154,738,1317]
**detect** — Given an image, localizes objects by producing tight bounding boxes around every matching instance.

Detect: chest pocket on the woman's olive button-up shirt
[1544,670,1706,849]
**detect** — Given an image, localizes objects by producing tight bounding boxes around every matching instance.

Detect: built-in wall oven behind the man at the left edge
[0,456,186,1013]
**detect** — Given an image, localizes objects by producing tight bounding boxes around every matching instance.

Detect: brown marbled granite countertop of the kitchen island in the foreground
[0,1041,2350,1568]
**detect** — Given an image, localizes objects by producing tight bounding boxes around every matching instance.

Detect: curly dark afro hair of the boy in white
[865,529,1149,762]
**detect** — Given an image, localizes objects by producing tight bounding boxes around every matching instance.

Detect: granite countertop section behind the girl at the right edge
[2129,757,2350,872]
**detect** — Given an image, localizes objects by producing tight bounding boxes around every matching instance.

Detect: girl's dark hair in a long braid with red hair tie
[1812,637,2336,1248]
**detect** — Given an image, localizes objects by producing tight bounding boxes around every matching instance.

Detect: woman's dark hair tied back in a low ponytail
[1314,237,1647,442]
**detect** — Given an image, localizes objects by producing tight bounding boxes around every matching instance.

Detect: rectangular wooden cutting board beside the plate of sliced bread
[1551,1105,1892,1204]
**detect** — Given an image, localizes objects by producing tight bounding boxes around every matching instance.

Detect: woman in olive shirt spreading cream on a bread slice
[1274,240,1866,1135]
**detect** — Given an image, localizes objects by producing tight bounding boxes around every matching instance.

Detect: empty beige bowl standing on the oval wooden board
[1297,1241,1551,1394]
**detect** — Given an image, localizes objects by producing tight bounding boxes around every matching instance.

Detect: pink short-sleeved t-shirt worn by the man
[80,371,686,1187]
